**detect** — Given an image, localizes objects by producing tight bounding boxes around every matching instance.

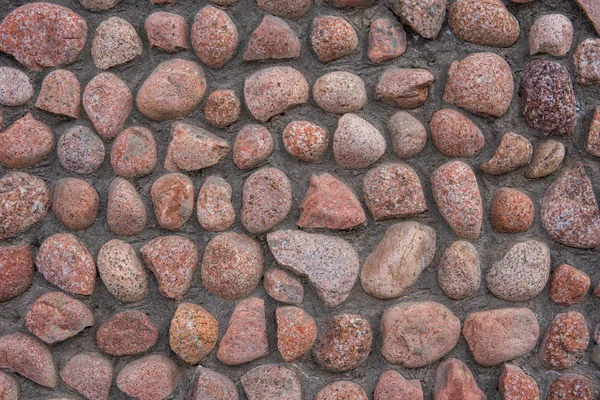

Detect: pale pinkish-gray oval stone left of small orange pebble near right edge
[485,240,550,301]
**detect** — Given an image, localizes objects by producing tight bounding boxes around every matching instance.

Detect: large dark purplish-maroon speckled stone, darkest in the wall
[521,60,577,136]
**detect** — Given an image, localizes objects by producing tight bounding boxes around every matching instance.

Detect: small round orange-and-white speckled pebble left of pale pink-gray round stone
[282,121,329,162]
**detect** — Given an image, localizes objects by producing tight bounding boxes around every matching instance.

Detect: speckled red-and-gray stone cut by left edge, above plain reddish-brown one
[0,172,50,240]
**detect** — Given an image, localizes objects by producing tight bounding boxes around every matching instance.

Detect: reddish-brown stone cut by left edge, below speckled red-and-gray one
[0,245,34,304]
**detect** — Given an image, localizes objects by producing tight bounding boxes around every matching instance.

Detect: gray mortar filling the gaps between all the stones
[0,0,600,400]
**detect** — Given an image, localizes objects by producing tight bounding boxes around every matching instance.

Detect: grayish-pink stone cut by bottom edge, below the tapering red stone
[241,364,302,400]
